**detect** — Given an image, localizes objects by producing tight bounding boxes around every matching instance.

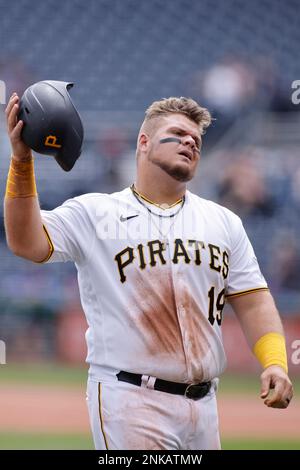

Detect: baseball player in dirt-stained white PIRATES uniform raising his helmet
[5,94,293,450]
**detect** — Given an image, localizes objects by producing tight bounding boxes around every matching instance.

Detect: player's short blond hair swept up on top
[142,96,212,135]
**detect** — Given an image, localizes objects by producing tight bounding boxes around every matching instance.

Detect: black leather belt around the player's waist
[117,370,211,400]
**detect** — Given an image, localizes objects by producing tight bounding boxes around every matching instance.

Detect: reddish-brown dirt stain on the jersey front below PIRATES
[129,266,215,382]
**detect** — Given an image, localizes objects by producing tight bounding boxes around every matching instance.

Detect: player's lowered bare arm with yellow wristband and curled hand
[229,290,293,408]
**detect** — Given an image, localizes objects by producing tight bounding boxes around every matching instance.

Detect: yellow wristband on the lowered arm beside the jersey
[253,333,288,373]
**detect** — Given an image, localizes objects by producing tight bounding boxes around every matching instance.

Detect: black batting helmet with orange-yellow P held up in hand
[18,80,83,171]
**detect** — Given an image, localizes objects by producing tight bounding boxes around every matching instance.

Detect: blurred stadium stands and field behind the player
[0,0,300,449]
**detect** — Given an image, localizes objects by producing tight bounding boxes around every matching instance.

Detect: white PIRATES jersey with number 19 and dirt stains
[42,188,267,382]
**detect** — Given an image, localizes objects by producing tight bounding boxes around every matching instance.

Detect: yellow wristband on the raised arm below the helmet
[5,158,37,198]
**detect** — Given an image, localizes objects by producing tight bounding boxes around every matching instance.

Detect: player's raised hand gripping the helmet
[5,93,32,162]
